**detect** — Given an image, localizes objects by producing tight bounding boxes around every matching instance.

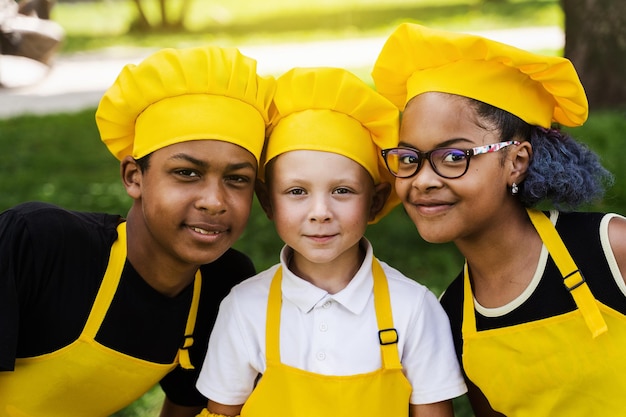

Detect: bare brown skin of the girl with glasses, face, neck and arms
[396,93,626,417]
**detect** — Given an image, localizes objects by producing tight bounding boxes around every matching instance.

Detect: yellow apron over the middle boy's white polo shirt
[241,259,411,417]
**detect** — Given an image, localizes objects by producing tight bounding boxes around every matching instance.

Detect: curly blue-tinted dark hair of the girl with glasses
[469,99,614,210]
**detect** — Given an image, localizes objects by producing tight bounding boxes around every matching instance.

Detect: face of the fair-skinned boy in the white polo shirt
[268,151,375,270]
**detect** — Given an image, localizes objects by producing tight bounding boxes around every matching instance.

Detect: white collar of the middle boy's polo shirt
[280,238,374,314]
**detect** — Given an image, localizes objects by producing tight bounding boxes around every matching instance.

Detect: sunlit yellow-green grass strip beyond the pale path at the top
[53,0,563,52]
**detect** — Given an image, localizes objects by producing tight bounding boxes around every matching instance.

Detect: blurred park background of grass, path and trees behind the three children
[0,0,626,417]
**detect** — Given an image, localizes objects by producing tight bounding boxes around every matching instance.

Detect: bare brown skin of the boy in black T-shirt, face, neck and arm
[121,140,257,417]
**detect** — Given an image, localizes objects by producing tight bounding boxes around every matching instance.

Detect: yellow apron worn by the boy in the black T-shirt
[0,223,201,417]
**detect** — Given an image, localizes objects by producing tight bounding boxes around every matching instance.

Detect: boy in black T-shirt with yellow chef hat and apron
[0,47,275,417]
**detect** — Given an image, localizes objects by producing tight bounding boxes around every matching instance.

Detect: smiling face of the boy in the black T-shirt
[133,140,257,265]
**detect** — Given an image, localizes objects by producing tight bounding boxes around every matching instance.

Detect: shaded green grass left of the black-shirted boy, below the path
[0,109,128,211]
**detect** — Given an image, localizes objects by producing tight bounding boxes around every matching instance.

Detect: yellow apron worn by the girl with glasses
[462,210,626,417]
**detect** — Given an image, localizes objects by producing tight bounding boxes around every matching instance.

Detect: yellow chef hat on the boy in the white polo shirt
[261,68,400,223]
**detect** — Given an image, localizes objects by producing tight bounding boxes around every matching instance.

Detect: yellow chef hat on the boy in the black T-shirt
[96,47,275,161]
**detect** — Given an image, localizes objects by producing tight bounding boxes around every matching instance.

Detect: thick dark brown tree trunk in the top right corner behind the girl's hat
[561,0,626,110]
